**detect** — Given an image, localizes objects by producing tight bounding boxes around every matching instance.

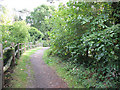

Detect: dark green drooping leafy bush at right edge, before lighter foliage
[81,25,120,61]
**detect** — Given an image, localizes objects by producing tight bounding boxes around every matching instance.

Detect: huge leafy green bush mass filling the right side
[49,1,120,87]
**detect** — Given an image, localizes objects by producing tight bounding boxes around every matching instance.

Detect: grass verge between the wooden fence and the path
[11,47,40,88]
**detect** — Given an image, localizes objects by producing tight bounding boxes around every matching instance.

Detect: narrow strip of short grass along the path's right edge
[43,49,84,88]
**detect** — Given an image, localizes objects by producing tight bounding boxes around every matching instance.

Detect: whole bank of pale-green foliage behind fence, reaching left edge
[0,21,30,48]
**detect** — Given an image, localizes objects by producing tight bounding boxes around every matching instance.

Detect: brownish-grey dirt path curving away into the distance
[29,47,67,88]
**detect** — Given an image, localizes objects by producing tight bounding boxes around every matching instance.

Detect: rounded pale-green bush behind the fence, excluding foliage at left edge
[10,21,29,43]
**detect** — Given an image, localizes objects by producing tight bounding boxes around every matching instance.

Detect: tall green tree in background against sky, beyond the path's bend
[26,5,54,39]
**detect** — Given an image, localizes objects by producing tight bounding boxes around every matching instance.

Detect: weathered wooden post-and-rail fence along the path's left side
[0,42,43,90]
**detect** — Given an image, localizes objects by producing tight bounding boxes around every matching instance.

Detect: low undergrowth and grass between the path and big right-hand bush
[43,49,118,88]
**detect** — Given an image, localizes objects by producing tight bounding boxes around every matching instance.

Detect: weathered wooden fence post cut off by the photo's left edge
[0,44,4,90]
